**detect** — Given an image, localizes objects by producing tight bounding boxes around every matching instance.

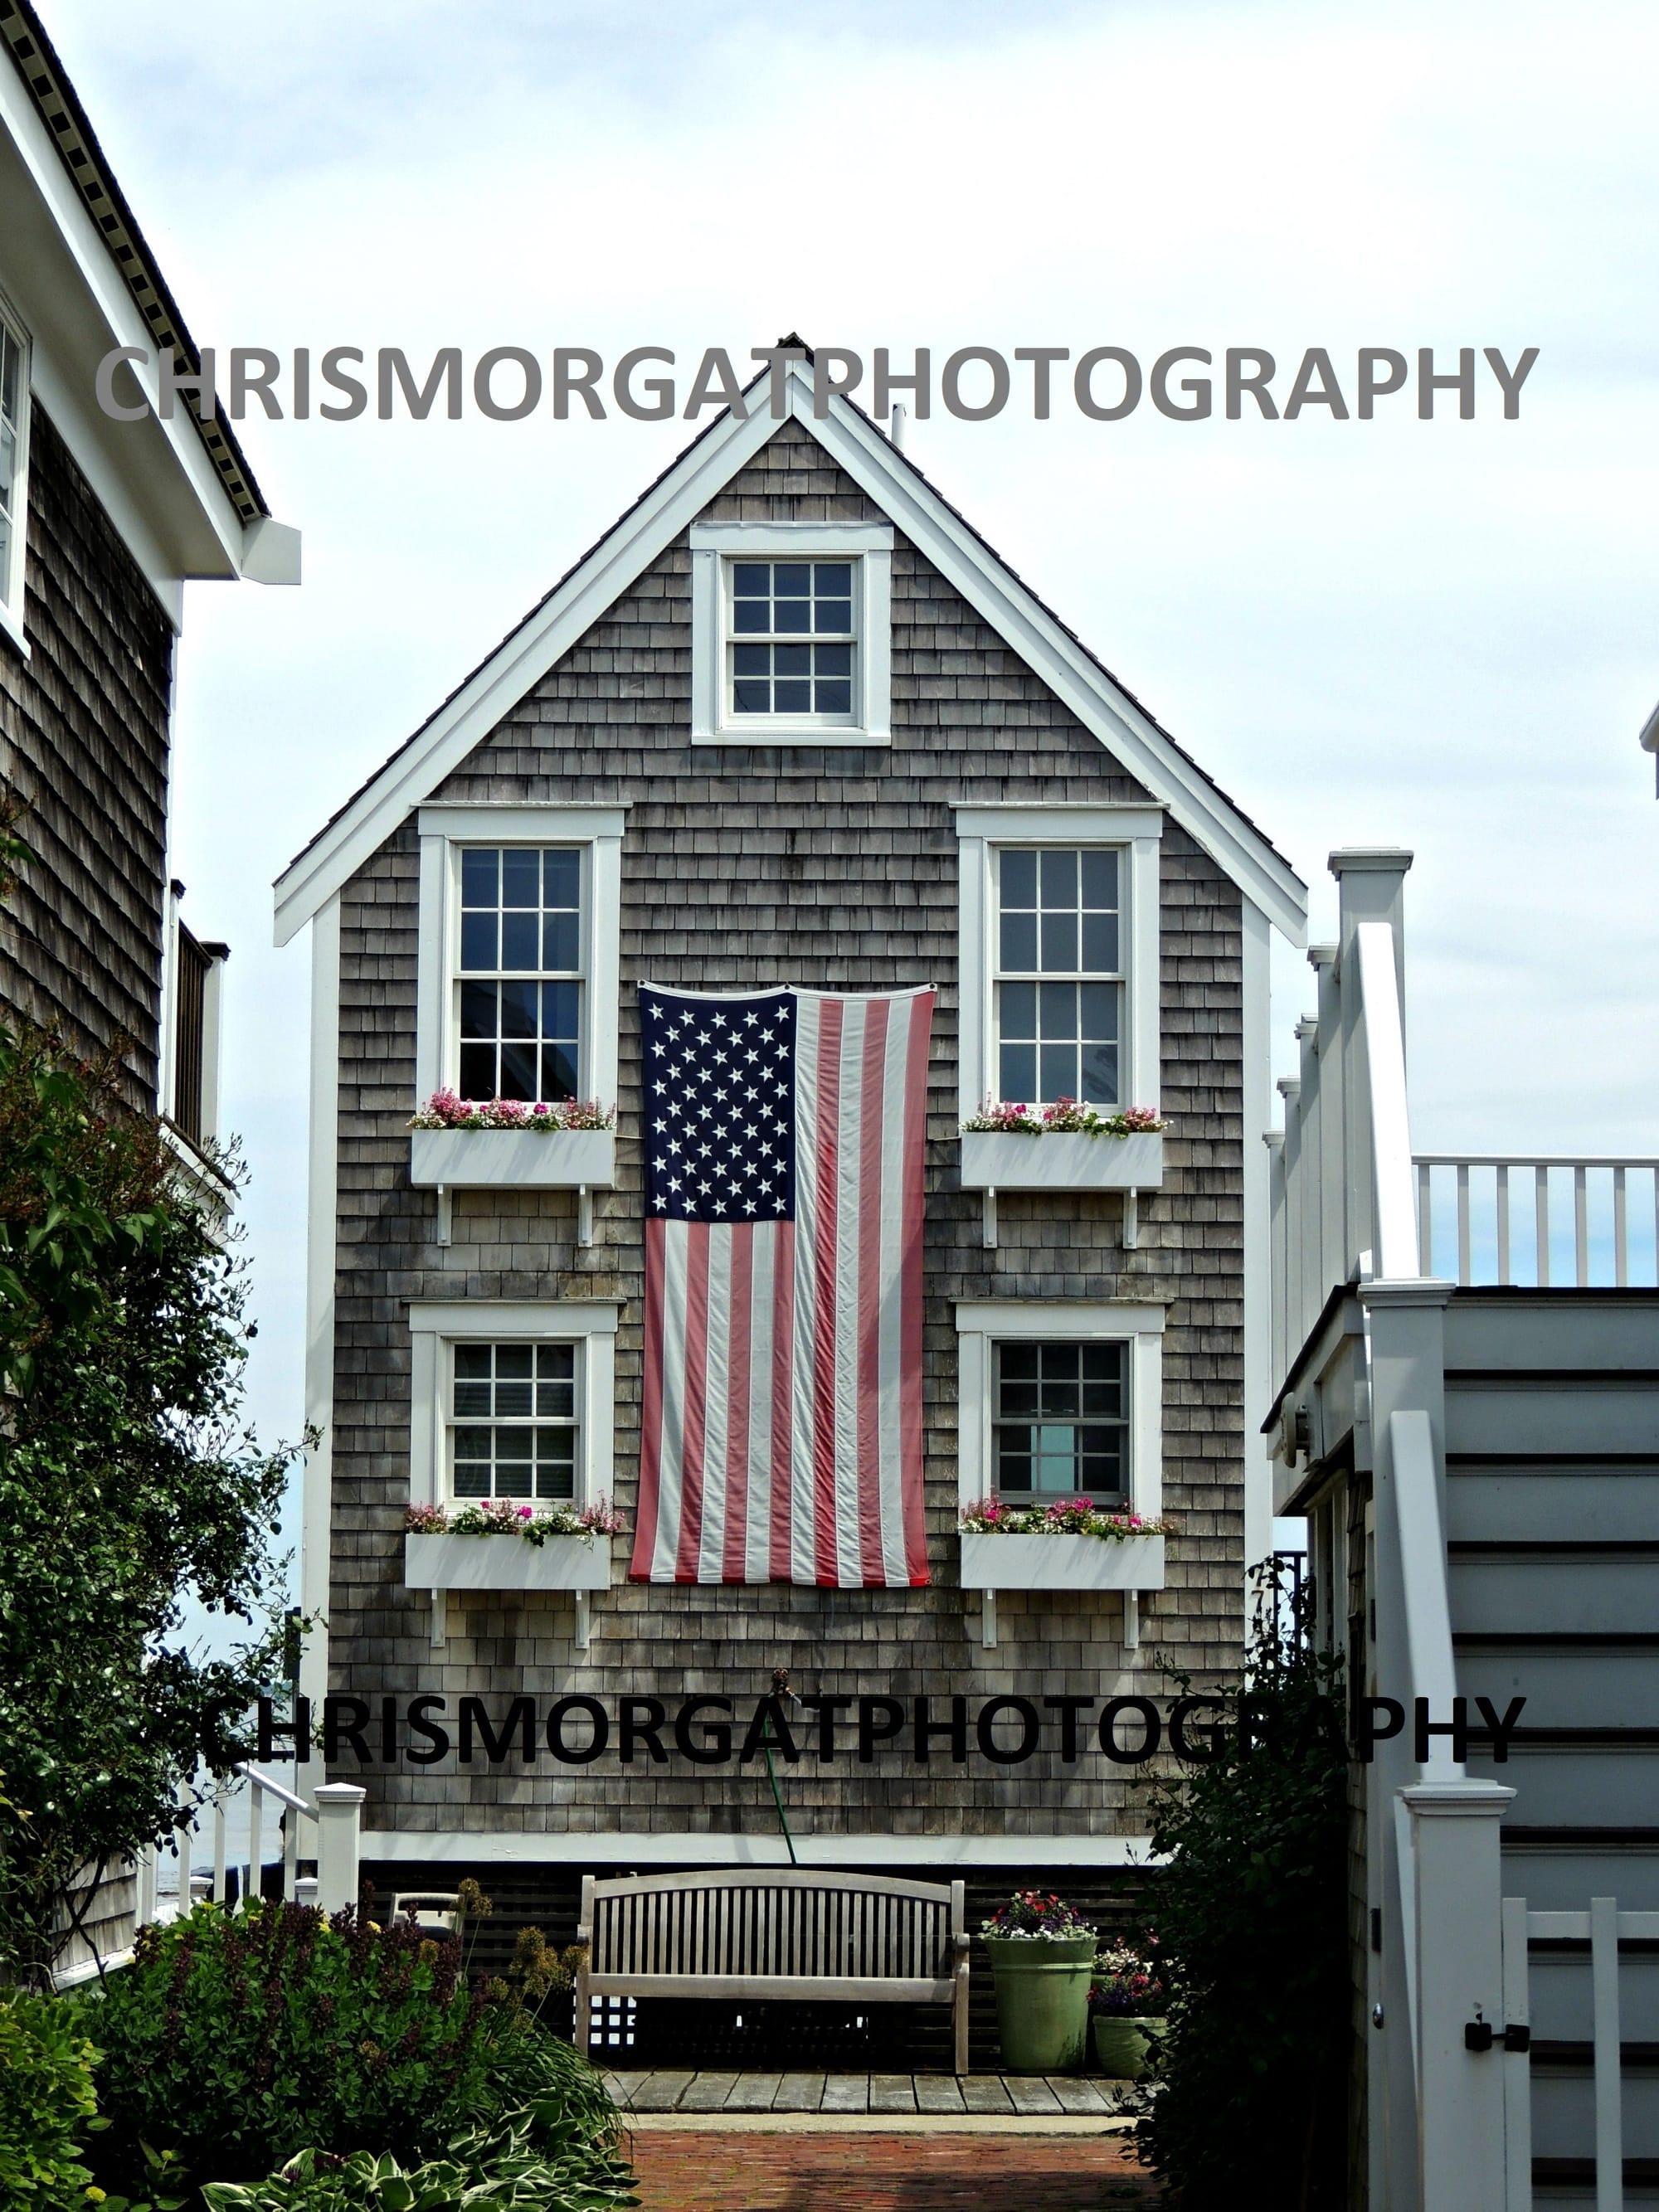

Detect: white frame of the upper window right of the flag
[956,800,1165,1121]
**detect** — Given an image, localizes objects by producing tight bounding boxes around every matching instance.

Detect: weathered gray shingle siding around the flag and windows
[329,422,1243,1834]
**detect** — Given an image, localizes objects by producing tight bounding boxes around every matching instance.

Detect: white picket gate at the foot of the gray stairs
[1504,1898,1659,2212]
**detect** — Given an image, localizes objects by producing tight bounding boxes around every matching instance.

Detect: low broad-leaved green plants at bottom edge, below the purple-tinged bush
[202,2088,640,2212]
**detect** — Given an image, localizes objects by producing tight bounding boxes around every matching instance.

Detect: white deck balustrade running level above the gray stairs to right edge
[1413,1153,1659,1290]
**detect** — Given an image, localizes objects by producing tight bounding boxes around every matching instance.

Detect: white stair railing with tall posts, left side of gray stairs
[1270,852,1513,2212]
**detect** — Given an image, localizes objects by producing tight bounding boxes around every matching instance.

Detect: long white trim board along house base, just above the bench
[361,1827,1161,1867]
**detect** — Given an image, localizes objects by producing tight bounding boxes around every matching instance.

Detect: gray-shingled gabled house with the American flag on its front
[276,369,1303,2035]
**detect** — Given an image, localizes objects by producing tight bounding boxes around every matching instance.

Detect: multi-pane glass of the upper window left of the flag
[458,845,581,1104]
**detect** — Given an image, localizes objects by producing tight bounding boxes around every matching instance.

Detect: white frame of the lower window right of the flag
[956,1299,1165,1519]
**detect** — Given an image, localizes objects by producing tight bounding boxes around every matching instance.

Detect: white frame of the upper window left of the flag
[416,805,628,1106]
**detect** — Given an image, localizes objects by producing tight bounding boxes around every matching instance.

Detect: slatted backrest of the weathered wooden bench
[591,1876,953,1982]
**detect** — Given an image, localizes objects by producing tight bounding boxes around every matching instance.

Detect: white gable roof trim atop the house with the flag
[276,358,1307,945]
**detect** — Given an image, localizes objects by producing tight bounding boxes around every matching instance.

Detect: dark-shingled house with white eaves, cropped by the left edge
[0,0,299,1161]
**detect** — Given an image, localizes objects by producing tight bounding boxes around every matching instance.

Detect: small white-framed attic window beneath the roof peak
[690,522,893,746]
